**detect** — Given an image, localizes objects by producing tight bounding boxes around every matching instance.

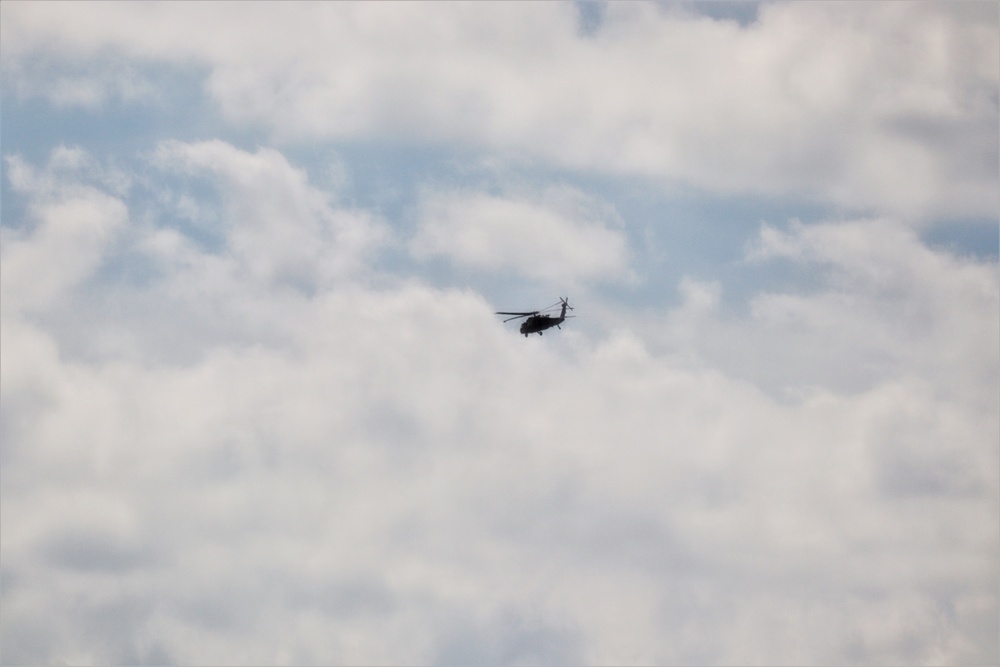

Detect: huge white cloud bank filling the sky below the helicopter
[0,149,1000,664]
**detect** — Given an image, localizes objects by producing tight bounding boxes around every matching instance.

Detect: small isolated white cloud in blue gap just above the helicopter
[412,187,628,287]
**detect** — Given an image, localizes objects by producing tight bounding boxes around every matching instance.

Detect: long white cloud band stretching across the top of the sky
[3,3,1000,218]
